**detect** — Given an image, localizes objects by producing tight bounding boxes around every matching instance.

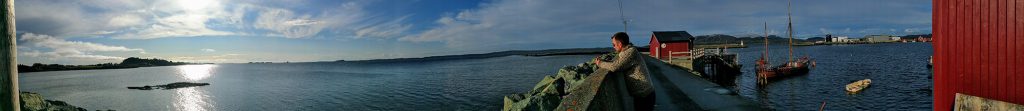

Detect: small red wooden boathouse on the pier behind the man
[648,31,693,59]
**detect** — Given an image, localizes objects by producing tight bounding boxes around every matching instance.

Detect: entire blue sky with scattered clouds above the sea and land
[14,0,932,65]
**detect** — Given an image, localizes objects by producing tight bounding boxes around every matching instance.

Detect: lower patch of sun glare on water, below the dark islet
[174,87,213,111]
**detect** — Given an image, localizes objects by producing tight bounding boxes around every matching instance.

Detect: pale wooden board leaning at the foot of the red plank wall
[953,93,1024,111]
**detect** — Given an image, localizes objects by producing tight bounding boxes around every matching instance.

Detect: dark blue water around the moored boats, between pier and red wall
[729,42,933,111]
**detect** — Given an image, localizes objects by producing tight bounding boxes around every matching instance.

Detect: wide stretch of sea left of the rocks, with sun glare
[20,56,593,111]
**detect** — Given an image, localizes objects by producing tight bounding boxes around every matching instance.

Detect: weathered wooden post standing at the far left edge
[0,0,20,111]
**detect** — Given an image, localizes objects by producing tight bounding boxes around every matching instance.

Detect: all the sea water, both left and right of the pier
[19,43,932,111]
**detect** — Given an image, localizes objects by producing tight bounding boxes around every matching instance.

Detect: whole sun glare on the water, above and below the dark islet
[174,65,217,111]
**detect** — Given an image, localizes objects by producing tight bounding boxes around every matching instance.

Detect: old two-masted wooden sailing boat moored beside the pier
[757,1,814,85]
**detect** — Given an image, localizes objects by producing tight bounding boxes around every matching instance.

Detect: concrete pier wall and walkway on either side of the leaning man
[555,57,765,111]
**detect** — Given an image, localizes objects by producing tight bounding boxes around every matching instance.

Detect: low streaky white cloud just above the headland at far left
[18,33,144,60]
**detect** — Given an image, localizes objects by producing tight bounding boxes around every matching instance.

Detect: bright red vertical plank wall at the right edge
[932,0,1024,111]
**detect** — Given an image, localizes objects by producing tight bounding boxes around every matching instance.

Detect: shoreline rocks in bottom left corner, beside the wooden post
[20,91,86,111]
